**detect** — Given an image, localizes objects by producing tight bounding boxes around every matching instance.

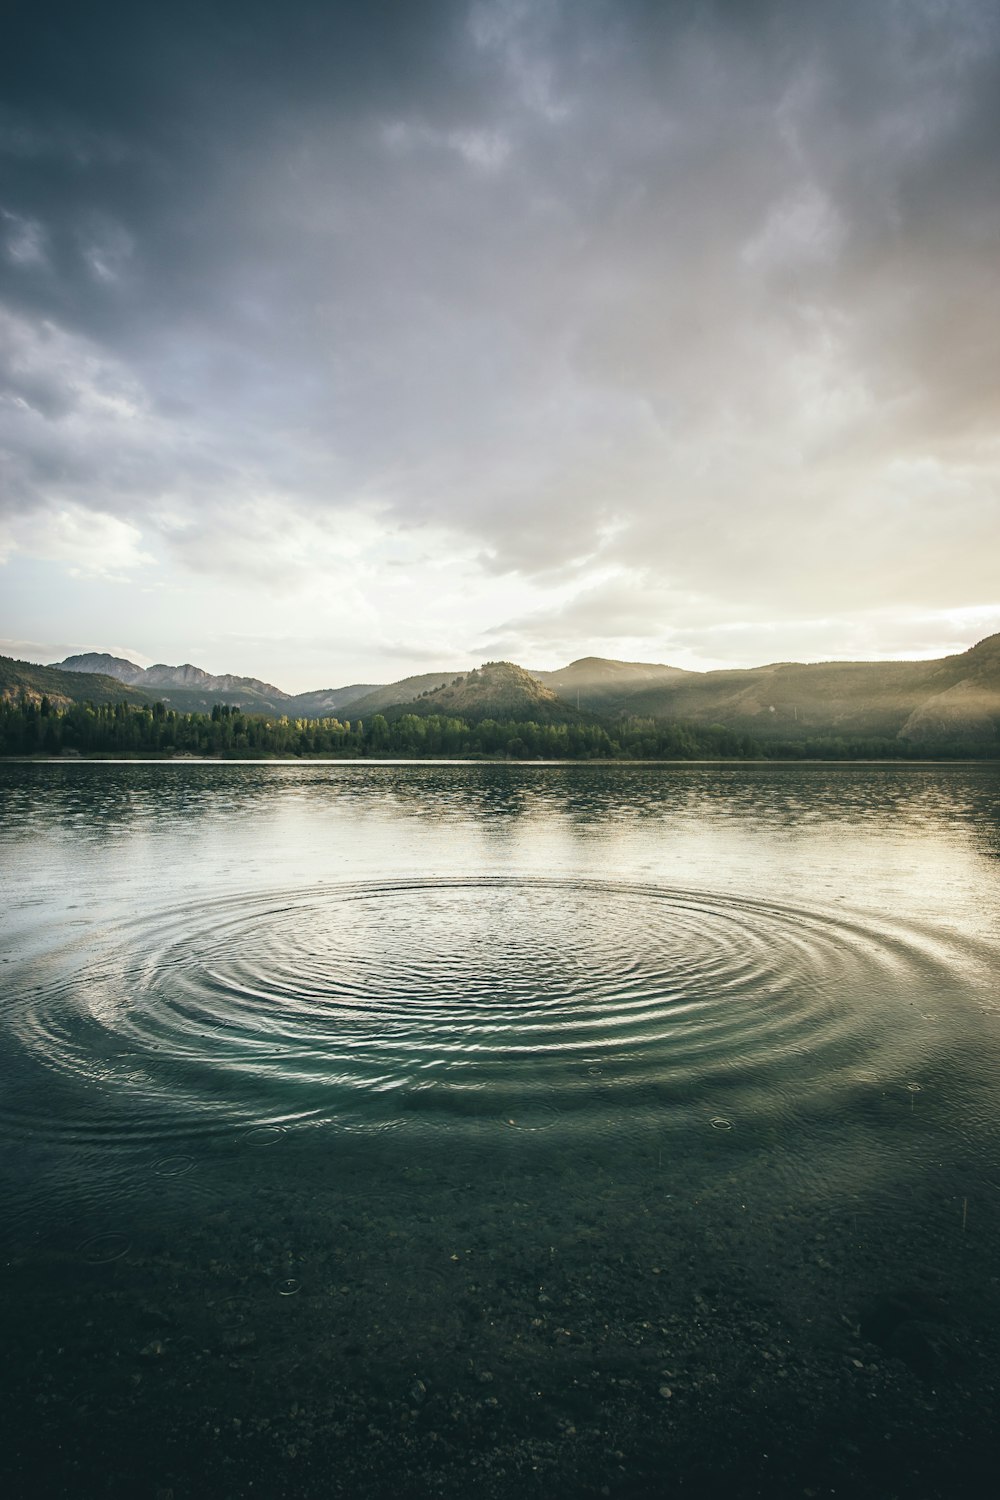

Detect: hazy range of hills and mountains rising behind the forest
[0,635,1000,752]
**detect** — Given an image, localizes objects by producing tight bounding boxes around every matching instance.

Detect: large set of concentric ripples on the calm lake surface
[6,878,971,1140]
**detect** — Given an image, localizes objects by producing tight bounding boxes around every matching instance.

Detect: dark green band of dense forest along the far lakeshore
[0,696,996,761]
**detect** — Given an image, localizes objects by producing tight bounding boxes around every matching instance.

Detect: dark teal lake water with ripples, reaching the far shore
[0,762,1000,1500]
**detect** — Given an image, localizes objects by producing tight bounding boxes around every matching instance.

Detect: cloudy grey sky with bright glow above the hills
[0,0,1000,692]
